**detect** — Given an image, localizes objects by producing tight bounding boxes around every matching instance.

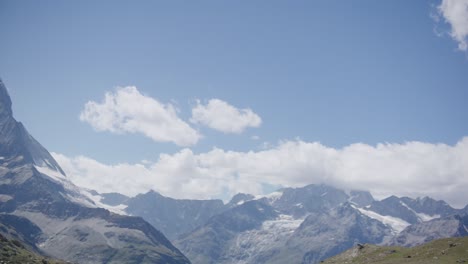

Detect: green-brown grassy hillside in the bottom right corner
[321,237,468,264]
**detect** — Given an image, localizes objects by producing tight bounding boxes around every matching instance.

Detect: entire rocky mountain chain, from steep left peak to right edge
[0,81,468,264]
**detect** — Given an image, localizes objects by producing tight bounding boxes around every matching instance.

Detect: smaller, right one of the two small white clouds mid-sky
[190,99,262,134]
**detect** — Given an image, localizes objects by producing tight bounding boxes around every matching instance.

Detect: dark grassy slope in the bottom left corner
[0,234,67,264]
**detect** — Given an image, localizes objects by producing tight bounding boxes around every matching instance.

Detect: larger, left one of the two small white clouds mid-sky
[80,86,201,146]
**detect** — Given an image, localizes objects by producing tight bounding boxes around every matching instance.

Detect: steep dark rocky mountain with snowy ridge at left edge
[0,81,190,263]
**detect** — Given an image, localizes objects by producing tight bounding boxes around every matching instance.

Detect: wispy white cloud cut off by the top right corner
[436,0,468,51]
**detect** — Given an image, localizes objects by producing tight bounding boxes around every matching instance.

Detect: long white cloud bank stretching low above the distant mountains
[53,137,468,207]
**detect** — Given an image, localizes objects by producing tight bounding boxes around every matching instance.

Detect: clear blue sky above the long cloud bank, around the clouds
[0,0,468,205]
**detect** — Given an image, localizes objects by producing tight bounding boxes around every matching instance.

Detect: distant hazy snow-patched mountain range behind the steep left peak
[99,184,468,264]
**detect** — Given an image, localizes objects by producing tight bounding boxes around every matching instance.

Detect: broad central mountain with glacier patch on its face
[175,184,392,264]
